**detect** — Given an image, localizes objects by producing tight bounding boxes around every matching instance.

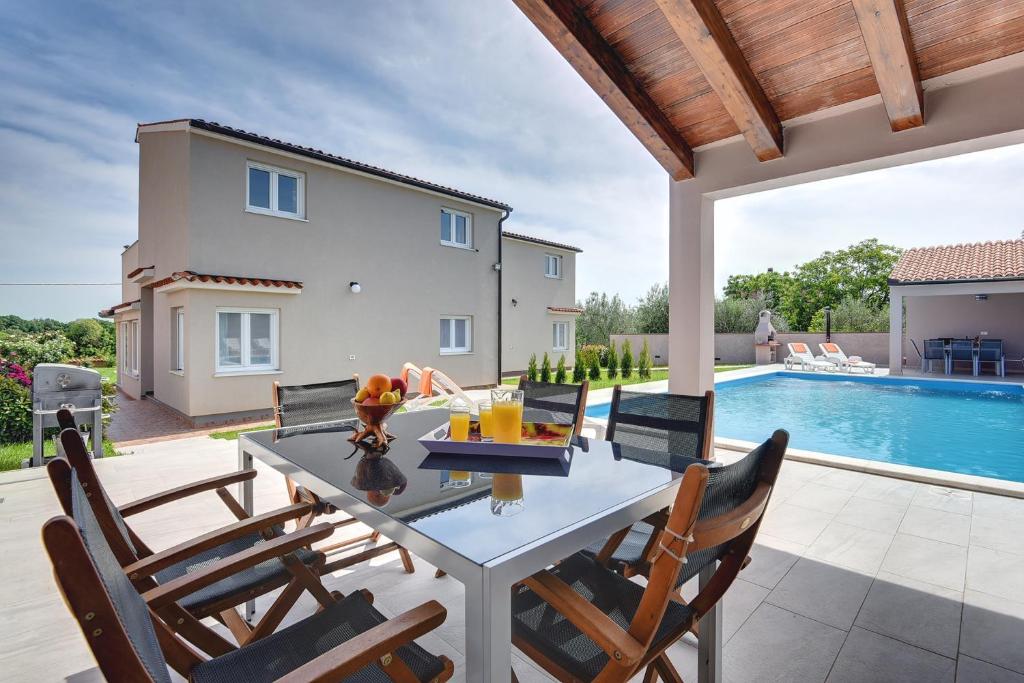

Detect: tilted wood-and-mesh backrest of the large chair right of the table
[630,429,790,644]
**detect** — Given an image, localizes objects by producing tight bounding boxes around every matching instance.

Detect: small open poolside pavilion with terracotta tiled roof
[889,239,1024,374]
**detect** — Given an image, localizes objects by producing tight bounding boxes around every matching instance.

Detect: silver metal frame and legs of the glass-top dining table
[239,434,722,683]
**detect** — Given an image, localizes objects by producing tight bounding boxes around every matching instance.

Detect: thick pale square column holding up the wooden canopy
[669,180,715,395]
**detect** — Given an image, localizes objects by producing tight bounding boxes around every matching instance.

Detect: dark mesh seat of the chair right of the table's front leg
[512,553,693,681]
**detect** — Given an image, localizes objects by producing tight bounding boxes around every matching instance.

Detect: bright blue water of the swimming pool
[587,373,1024,481]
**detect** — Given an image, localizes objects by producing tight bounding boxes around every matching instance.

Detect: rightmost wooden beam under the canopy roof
[853,0,925,132]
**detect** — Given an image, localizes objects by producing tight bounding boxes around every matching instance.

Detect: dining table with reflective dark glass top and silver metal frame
[239,410,721,681]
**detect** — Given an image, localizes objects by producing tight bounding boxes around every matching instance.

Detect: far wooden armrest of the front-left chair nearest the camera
[142,522,334,610]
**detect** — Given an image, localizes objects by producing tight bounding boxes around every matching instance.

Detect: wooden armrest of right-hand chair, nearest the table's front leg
[522,569,646,666]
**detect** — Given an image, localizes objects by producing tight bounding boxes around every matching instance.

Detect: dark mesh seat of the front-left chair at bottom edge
[191,591,444,683]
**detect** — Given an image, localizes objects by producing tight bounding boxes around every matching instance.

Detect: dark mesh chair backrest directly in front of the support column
[605,385,715,460]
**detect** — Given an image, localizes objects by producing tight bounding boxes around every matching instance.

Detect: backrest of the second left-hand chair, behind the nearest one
[57,429,153,566]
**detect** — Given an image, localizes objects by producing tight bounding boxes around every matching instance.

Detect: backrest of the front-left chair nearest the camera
[43,471,171,683]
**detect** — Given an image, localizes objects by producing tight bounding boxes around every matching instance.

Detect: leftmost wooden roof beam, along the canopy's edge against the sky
[514,0,693,180]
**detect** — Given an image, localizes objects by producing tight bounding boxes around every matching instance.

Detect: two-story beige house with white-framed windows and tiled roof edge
[107,119,580,424]
